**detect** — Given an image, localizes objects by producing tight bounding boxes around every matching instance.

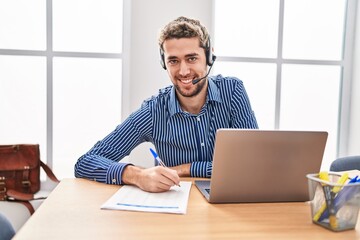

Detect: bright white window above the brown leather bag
[0,0,123,178]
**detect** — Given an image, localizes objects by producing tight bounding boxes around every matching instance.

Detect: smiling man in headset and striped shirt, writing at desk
[75,17,258,192]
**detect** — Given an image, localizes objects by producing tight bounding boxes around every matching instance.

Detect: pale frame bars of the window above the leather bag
[0,0,131,186]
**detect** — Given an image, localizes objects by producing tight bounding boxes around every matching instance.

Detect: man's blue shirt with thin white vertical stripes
[75,75,258,184]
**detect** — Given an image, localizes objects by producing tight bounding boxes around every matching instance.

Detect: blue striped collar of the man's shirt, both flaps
[169,77,222,116]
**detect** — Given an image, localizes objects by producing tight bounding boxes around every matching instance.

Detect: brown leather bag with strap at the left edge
[0,144,59,212]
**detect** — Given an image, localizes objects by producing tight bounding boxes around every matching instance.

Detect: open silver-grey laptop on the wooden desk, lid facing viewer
[195,129,328,203]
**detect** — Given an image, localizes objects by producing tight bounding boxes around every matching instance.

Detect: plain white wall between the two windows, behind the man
[123,0,212,166]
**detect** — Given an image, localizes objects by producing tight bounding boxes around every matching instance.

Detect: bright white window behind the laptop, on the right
[214,0,356,169]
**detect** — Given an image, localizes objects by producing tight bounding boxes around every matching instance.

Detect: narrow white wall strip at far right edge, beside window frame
[348,3,360,155]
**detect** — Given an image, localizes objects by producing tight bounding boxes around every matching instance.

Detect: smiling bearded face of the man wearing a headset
[163,37,207,97]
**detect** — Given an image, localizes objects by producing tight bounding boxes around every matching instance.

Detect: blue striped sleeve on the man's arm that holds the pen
[75,105,152,184]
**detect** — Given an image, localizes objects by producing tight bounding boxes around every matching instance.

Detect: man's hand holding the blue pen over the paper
[122,165,180,192]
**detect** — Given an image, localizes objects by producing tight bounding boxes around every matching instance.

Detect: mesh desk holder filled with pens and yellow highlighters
[306,173,360,231]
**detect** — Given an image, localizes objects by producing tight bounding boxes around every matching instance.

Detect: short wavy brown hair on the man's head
[159,16,209,49]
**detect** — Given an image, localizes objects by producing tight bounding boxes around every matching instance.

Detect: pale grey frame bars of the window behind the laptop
[211,0,357,158]
